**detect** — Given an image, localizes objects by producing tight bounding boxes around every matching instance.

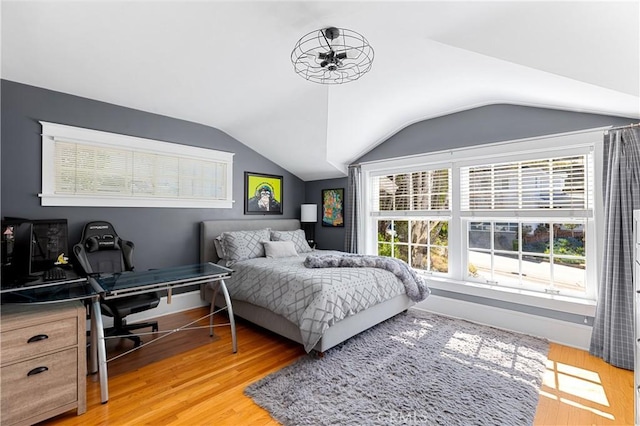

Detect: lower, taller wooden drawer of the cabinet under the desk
[0,348,78,425]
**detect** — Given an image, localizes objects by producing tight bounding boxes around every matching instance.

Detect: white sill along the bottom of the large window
[425,276,596,317]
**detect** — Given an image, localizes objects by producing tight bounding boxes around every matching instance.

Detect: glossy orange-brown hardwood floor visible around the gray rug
[43,308,633,425]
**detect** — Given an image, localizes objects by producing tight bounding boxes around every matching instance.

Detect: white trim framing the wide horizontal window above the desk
[38,121,234,208]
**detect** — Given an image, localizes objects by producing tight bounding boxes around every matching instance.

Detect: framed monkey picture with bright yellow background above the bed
[244,172,283,215]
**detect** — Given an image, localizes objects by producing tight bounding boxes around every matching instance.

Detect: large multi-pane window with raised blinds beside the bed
[363,131,602,300]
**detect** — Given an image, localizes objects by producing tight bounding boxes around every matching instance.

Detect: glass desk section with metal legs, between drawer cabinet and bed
[88,263,238,404]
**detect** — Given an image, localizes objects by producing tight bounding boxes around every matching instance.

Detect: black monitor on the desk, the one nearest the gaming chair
[29,219,70,275]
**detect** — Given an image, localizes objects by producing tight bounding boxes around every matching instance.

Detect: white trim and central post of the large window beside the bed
[358,127,609,316]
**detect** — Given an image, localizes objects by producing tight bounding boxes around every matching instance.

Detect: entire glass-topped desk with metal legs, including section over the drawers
[0,263,238,404]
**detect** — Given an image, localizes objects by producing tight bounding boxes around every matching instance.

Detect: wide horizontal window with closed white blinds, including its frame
[41,122,233,208]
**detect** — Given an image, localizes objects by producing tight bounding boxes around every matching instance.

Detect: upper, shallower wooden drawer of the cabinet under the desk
[0,317,78,364]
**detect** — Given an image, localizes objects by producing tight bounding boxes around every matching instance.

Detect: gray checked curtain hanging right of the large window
[589,126,640,370]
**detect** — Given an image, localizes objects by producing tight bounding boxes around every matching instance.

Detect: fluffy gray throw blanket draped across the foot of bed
[304,253,431,302]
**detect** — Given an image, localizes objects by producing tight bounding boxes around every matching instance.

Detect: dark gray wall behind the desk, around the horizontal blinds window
[0,80,305,269]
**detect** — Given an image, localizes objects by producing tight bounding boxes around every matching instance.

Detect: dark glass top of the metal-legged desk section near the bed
[92,263,233,294]
